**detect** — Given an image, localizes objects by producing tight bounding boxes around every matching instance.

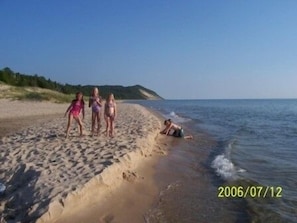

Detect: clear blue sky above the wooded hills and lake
[0,0,297,99]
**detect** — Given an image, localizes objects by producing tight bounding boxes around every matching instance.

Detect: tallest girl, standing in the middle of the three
[89,87,102,136]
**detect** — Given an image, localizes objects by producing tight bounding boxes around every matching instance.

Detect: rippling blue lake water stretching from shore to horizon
[135,99,297,222]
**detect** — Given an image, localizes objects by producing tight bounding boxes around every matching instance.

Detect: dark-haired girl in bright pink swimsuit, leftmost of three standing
[65,92,85,138]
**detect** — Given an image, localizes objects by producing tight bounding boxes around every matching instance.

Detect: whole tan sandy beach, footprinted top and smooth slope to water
[0,99,167,222]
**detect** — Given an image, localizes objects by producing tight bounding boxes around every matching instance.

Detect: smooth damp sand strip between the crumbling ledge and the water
[49,134,168,223]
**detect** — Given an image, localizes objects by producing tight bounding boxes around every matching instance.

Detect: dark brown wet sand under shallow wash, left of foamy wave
[145,133,249,223]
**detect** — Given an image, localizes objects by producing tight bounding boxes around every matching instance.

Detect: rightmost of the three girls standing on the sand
[104,94,117,137]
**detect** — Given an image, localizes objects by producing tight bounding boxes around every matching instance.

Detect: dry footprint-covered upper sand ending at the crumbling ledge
[0,100,162,222]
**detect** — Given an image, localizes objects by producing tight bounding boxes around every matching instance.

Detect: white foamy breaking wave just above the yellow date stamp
[211,155,245,180]
